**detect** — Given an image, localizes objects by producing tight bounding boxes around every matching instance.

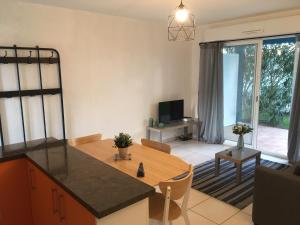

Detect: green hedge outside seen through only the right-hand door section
[259,43,295,129]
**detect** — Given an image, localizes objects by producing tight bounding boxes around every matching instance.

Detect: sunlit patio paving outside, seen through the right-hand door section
[257,125,288,157]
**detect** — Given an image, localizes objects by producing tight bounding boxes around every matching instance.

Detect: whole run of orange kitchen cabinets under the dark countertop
[0,158,96,225]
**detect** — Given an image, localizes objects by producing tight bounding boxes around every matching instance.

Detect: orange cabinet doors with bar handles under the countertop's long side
[28,160,96,225]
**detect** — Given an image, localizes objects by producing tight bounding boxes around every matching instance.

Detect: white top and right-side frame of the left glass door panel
[224,39,263,148]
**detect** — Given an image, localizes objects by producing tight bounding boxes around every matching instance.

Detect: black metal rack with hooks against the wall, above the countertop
[0,45,66,150]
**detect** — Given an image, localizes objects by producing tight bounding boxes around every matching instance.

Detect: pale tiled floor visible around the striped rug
[164,140,286,225]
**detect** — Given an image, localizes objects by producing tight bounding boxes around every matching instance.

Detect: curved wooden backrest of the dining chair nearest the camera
[159,165,193,200]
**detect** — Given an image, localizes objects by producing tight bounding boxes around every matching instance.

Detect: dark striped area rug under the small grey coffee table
[192,160,288,209]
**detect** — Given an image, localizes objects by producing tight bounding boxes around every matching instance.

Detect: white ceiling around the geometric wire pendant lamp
[20,0,300,24]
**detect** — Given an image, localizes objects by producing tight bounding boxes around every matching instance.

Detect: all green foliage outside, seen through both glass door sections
[224,40,295,129]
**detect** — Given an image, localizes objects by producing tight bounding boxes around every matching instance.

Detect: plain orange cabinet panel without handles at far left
[0,159,32,225]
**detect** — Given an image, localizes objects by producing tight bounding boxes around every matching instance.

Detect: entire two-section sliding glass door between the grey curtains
[223,37,296,157]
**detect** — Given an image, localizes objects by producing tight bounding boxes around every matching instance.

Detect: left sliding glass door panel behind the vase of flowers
[223,41,261,145]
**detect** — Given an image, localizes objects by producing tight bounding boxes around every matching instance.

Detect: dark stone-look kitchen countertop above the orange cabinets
[0,139,155,218]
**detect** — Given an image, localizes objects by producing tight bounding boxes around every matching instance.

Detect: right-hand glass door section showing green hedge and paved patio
[256,37,296,157]
